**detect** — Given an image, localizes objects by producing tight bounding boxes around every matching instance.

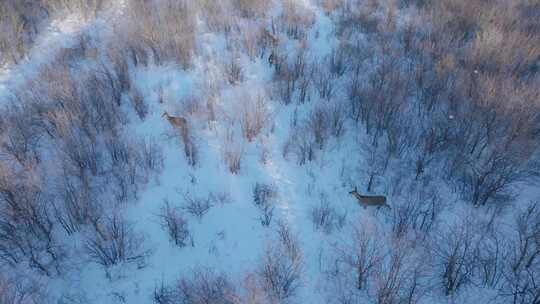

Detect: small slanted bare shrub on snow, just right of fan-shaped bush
[159,200,193,247]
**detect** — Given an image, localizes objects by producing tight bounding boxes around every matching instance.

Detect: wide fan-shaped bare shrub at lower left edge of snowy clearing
[85,212,149,267]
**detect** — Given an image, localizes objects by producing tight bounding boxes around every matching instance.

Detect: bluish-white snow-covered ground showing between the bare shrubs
[0,0,536,304]
